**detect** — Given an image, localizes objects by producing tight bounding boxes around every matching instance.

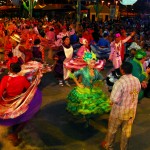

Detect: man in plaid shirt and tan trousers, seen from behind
[102,62,141,150]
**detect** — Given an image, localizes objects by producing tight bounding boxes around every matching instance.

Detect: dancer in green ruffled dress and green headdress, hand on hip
[67,52,111,118]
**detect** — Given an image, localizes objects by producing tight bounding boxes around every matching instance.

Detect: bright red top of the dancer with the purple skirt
[0,75,30,98]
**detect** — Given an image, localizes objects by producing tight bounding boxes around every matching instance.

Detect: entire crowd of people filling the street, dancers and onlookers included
[0,15,150,150]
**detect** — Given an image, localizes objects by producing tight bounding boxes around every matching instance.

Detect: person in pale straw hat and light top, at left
[10,34,25,63]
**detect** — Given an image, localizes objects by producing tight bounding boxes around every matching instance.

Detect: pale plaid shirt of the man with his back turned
[110,74,141,120]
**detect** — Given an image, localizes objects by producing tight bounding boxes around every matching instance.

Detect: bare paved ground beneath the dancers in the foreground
[0,64,150,150]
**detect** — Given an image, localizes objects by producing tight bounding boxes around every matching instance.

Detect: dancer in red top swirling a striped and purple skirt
[0,63,42,146]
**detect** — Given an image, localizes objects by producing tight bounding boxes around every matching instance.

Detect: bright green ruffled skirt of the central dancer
[67,87,111,116]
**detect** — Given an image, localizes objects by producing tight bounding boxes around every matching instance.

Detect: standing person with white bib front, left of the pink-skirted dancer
[54,36,73,86]
